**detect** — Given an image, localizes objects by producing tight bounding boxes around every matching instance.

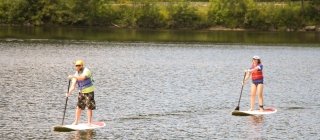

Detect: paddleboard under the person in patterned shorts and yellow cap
[53,122,106,132]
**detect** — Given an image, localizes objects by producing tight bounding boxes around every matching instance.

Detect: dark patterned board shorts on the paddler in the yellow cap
[77,92,96,110]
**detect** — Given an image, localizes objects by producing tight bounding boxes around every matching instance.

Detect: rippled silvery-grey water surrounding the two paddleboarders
[0,42,320,139]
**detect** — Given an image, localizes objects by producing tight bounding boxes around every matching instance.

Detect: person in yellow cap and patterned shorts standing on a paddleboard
[66,60,96,125]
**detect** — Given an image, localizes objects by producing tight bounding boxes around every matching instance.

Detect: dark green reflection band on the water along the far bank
[0,27,320,45]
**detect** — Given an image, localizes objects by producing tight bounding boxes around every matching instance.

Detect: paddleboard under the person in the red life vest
[232,107,277,116]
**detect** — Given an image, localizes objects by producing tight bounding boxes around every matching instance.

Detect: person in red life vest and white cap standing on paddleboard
[243,56,264,112]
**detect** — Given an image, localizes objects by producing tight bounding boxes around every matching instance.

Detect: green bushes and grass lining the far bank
[0,0,320,32]
